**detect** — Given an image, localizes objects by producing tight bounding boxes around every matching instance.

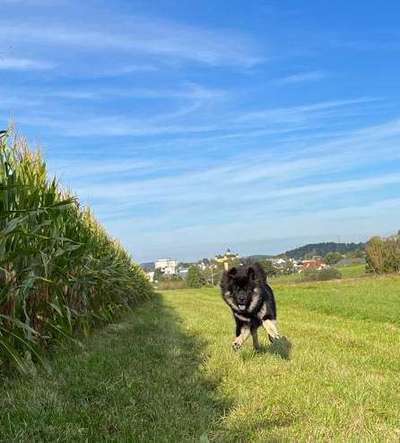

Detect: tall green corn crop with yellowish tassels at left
[0,130,152,371]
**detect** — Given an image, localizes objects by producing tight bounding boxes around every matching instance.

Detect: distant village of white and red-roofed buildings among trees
[142,249,365,285]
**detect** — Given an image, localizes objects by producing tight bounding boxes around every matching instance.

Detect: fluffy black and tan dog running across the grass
[220,263,280,351]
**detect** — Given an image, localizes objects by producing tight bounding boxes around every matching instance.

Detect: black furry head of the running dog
[221,265,265,311]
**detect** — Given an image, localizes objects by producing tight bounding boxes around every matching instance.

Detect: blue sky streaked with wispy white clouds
[0,0,400,261]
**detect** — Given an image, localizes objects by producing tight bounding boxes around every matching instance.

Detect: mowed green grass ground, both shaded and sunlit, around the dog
[0,277,400,443]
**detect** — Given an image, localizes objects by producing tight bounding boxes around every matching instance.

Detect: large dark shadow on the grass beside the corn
[0,296,230,442]
